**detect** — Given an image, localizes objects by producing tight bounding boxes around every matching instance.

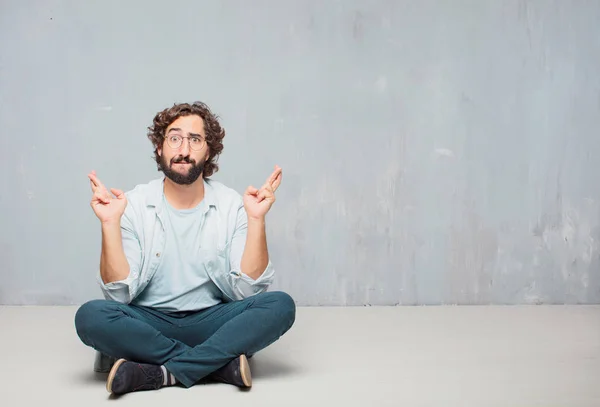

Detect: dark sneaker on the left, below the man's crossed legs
[106,359,164,394]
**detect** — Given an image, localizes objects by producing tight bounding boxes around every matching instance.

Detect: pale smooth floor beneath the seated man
[0,306,600,407]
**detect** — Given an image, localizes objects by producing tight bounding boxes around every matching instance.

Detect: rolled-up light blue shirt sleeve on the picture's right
[229,203,275,299]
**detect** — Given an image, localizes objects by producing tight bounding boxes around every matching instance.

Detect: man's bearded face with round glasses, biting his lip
[158,115,208,185]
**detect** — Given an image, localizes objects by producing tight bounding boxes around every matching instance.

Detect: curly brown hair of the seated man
[148,102,225,178]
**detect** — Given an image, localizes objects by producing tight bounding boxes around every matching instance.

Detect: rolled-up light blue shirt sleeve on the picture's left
[97,211,142,304]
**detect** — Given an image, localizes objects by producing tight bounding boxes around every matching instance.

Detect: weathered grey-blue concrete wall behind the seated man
[0,0,600,305]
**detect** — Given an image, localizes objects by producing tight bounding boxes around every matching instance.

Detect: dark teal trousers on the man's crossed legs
[75,292,296,387]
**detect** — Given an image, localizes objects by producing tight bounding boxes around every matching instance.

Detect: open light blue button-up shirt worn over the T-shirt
[97,177,274,304]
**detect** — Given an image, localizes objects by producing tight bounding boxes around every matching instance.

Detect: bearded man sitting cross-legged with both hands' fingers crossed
[75,102,296,394]
